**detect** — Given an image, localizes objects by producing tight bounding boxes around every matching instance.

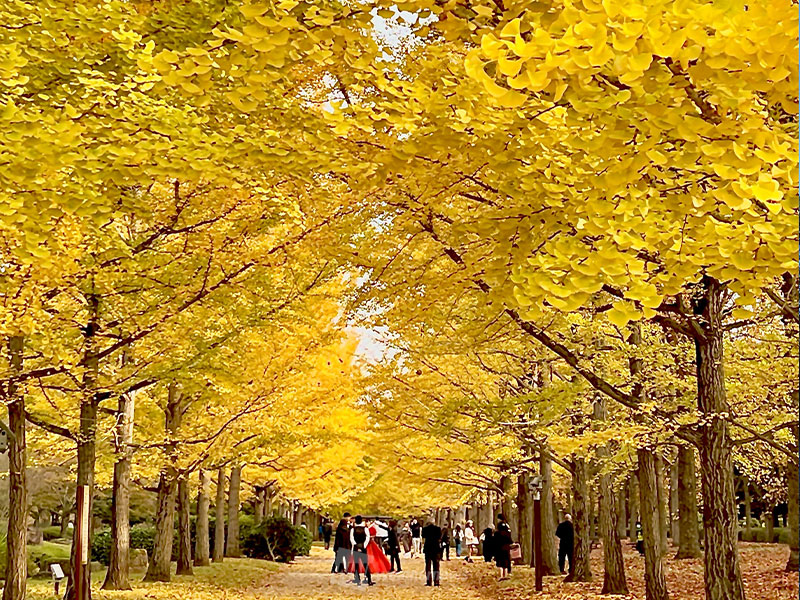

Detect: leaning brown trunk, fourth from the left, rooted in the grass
[144,382,183,581]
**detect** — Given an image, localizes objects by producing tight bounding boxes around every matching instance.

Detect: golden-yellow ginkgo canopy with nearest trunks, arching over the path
[0,0,798,600]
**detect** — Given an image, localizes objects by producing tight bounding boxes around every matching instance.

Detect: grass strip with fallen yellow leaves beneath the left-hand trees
[27,558,280,600]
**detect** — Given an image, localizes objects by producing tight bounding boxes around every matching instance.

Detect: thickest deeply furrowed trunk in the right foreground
[694,277,744,600]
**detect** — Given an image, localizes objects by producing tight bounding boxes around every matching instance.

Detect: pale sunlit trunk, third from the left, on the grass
[103,376,134,590]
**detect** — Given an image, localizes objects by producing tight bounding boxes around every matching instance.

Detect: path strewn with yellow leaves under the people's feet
[254,547,488,600]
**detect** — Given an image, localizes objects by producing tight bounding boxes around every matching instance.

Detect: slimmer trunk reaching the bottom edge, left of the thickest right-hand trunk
[637,448,669,600]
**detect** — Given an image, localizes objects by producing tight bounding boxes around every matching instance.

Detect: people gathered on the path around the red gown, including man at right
[320,513,574,586]
